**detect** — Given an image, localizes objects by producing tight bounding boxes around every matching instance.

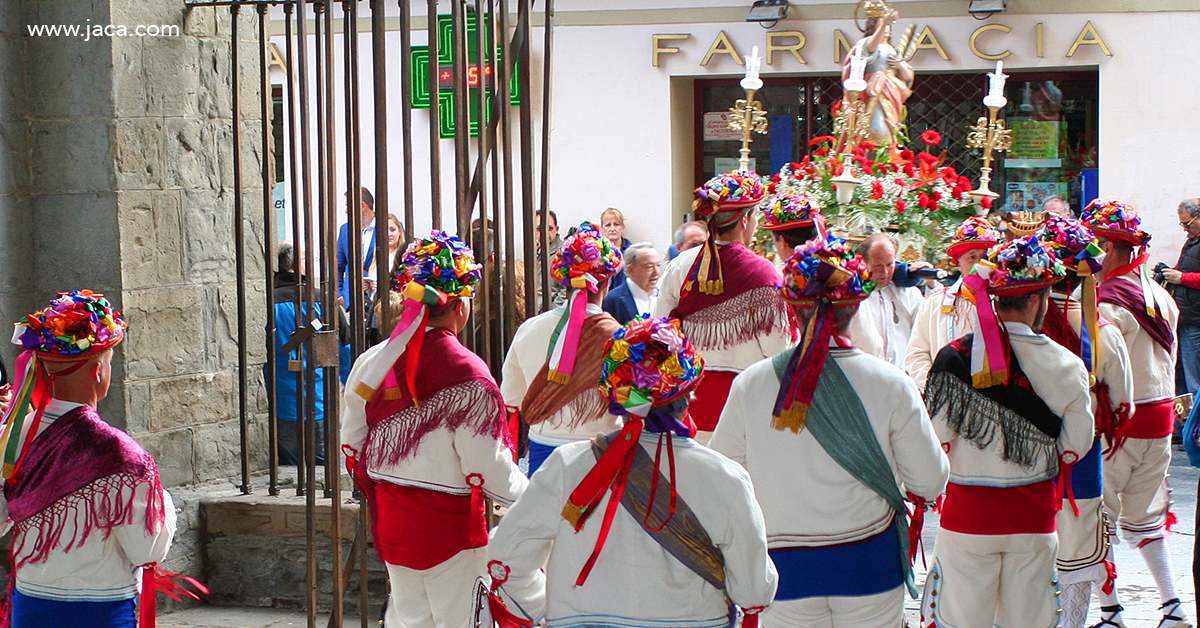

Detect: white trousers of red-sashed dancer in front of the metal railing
[384,548,487,628]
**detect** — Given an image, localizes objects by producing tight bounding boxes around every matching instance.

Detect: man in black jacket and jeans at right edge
[1154,198,1200,395]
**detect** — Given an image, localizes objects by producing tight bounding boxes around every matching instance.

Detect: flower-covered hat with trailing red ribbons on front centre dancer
[563,317,704,586]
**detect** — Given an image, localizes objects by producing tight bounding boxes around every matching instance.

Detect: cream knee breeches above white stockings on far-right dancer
[1104,437,1171,546]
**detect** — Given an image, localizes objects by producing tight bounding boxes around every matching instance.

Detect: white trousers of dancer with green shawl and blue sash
[762,586,905,628]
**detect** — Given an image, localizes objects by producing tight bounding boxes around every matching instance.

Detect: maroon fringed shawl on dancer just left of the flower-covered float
[671,243,793,351]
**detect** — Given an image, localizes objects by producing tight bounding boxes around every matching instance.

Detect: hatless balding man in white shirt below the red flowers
[850,233,922,369]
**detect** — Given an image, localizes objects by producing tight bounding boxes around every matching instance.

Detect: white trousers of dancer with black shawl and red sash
[920,528,1058,628]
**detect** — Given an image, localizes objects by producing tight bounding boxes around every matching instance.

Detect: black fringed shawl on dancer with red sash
[925,335,1062,472]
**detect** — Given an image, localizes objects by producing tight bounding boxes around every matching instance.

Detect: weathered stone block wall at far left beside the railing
[0,0,273,605]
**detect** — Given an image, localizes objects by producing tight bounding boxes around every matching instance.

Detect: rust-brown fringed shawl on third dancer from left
[521,313,620,427]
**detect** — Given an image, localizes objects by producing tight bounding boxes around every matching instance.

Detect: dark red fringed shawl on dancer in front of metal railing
[360,328,514,469]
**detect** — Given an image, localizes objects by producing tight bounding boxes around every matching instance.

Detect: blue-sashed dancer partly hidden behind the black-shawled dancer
[1038,214,1133,628]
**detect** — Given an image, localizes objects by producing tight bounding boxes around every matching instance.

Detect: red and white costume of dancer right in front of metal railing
[342,328,528,628]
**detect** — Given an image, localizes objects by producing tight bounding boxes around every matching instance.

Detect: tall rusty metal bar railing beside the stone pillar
[186,0,553,628]
